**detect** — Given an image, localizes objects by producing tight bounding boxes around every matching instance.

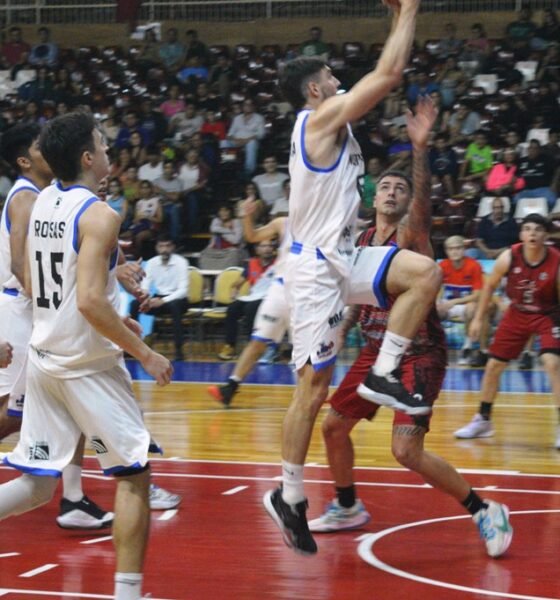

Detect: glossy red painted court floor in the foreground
[0,459,560,600]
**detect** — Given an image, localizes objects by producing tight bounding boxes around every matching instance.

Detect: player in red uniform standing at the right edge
[455,214,560,450]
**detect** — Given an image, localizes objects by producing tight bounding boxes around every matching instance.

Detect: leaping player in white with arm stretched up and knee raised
[263,0,441,554]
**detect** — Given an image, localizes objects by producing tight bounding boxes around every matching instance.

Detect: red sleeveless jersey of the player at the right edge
[506,244,560,314]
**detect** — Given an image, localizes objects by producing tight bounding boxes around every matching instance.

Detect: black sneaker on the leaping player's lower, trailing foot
[263,487,317,556]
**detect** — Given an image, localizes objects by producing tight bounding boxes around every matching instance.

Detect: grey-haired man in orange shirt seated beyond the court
[436,235,483,365]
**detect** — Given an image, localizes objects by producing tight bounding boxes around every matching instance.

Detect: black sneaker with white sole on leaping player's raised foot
[357,369,432,415]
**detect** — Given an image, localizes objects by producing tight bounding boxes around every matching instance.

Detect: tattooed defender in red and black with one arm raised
[309,98,511,556]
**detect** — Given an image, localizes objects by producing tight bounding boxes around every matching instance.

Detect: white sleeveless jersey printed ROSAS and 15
[28,182,121,379]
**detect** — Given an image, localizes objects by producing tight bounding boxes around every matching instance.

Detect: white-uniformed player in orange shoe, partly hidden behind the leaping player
[208,197,291,407]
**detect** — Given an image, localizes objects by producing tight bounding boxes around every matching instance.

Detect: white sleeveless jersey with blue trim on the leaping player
[289,110,364,275]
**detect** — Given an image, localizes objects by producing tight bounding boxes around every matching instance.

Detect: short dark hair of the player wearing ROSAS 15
[39,111,97,181]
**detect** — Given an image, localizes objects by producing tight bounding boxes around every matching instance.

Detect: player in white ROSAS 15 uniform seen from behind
[0,112,172,600]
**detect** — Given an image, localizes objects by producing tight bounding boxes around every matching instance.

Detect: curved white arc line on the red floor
[358,509,560,600]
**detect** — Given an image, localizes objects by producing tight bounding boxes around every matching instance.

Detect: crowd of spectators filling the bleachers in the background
[0,8,560,256]
